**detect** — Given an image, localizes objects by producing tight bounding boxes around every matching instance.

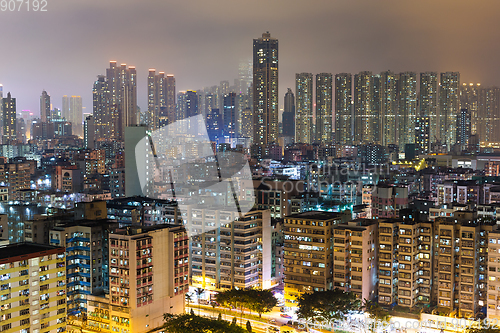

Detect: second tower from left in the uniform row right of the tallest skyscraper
[316,73,333,143]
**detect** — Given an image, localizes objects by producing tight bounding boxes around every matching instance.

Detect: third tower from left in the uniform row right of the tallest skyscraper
[335,73,353,146]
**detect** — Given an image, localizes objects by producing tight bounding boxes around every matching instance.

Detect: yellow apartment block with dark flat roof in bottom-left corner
[0,243,66,333]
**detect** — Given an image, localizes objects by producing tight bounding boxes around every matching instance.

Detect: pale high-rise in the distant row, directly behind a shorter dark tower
[418,72,439,143]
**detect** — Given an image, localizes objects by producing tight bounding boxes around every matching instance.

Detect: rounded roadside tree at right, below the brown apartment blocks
[297,288,361,324]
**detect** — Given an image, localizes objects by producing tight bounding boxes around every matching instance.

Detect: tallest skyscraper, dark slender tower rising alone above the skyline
[253,32,279,146]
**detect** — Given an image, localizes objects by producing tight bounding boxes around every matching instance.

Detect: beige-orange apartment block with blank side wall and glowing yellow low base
[87,225,189,333]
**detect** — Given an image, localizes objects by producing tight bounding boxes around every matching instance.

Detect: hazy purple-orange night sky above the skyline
[0,0,500,114]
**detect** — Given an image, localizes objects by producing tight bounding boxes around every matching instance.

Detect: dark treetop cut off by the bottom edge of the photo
[162,314,245,333]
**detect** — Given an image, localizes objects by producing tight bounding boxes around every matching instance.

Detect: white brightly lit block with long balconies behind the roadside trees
[185,207,276,291]
